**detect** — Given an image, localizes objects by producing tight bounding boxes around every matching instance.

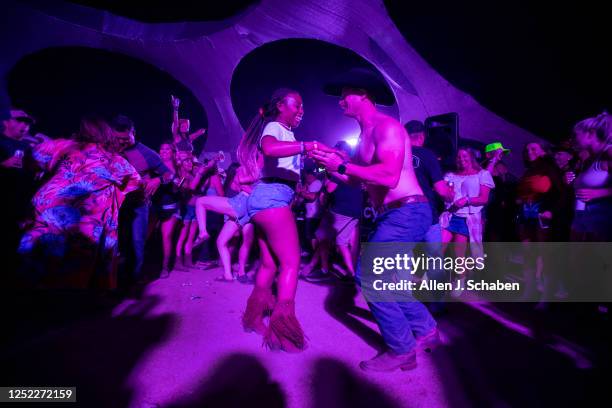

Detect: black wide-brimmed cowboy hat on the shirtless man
[323,68,395,106]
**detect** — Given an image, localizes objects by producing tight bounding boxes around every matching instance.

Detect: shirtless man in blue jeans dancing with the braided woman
[311,71,439,371]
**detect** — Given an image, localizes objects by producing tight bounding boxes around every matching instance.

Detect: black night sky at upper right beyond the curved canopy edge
[385,0,612,140]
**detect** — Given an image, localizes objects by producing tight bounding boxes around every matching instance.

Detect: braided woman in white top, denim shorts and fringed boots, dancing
[238,89,328,352]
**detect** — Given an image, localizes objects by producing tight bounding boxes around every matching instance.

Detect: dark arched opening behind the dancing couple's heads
[231,39,398,148]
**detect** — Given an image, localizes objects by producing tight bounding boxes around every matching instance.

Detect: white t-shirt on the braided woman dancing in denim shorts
[259,122,300,182]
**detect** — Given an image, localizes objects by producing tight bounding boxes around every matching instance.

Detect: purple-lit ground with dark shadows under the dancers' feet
[0,262,612,408]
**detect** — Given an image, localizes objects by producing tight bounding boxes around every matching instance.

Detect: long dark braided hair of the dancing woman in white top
[236,88,298,176]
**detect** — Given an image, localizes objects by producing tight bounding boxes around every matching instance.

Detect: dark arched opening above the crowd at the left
[7,47,208,148]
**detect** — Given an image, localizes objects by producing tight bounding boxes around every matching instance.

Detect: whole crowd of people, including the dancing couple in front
[0,70,612,371]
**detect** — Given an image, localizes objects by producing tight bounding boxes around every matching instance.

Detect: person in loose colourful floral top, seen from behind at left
[19,118,140,288]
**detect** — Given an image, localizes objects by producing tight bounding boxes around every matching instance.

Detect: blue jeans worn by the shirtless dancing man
[356,203,436,354]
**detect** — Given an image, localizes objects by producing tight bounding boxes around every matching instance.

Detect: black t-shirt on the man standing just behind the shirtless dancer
[412,146,444,224]
